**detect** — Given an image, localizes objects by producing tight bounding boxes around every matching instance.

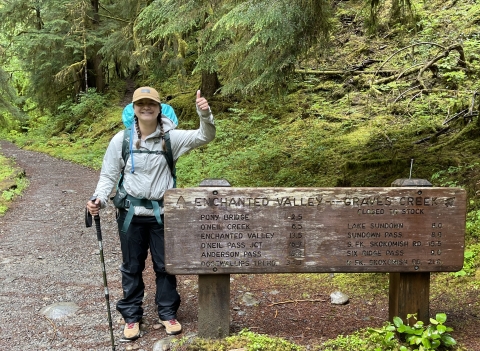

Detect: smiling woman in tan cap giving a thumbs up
[87,87,215,340]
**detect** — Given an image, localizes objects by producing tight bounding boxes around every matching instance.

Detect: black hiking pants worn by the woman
[117,210,180,323]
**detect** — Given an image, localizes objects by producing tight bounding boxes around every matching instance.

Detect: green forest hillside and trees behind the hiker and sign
[0,0,480,350]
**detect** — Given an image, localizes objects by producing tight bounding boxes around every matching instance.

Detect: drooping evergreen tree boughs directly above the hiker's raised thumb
[136,0,331,96]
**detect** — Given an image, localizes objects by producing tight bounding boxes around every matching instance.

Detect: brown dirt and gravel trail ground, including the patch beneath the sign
[0,141,480,351]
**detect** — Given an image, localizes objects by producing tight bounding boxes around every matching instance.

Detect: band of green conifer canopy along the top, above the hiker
[0,0,412,119]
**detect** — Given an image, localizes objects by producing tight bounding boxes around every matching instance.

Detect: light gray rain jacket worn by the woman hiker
[94,108,215,216]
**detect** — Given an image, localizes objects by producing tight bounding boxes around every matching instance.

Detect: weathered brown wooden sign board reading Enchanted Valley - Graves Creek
[164,187,466,274]
